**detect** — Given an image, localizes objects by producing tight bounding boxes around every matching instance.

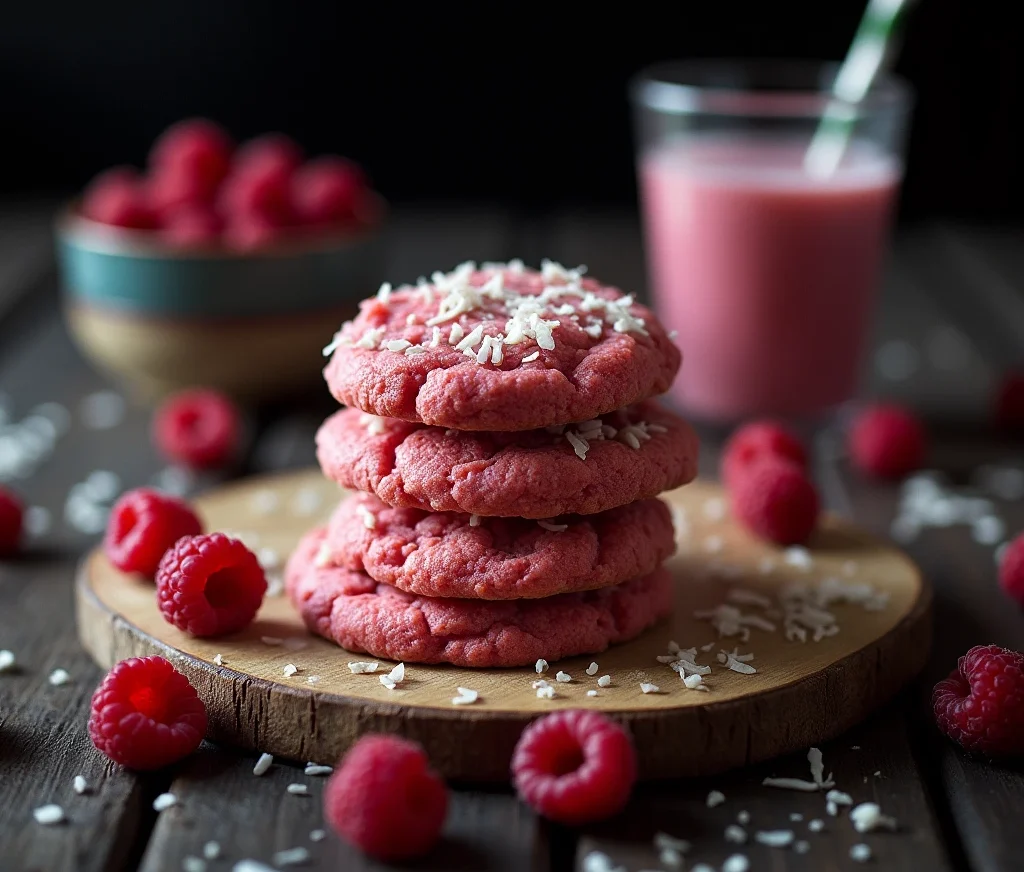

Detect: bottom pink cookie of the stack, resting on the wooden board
[286,528,673,667]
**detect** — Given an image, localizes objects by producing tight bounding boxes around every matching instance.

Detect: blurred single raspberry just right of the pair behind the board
[848,403,928,478]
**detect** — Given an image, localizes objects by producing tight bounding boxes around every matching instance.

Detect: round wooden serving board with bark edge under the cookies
[77,472,931,780]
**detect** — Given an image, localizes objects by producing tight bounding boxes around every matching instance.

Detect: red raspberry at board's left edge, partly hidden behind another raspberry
[103,487,203,578]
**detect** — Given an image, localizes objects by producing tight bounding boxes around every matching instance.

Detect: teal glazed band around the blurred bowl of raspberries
[57,215,380,318]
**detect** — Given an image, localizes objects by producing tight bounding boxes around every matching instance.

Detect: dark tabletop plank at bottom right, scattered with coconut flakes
[577,700,952,872]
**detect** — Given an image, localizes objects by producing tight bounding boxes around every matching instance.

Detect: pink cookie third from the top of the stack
[328,493,676,600]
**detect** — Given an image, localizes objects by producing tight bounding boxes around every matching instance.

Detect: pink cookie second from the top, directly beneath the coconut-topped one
[316,401,697,518]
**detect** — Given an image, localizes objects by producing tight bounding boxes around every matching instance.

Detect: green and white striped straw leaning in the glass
[804,0,912,178]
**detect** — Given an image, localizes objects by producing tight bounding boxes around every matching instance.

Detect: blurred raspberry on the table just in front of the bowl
[153,388,242,469]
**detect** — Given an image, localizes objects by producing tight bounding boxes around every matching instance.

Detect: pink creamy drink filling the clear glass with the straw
[640,136,901,422]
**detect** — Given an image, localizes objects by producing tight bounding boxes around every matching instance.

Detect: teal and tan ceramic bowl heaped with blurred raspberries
[57,119,386,400]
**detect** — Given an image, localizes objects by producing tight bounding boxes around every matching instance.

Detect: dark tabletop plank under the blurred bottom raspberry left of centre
[140,746,547,872]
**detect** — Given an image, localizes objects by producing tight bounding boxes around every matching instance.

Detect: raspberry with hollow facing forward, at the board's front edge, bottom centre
[512,709,637,825]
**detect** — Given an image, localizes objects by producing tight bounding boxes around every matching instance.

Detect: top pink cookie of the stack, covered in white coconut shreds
[324,261,682,430]
